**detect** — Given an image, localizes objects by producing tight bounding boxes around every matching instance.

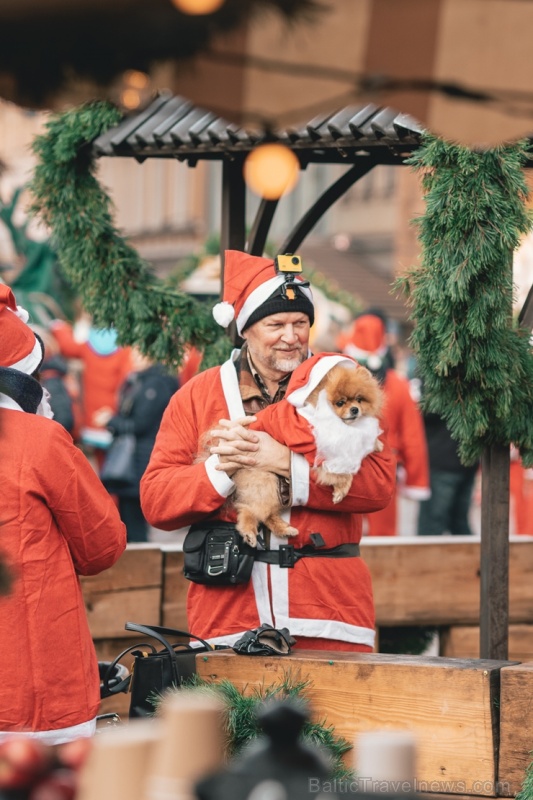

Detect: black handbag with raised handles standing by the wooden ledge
[103,622,215,718]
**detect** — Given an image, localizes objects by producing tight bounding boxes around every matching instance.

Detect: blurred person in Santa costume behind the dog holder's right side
[337,310,431,536]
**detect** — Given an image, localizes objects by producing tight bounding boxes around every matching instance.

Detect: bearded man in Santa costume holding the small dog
[141,250,395,652]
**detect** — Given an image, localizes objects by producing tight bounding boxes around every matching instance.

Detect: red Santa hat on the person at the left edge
[0,284,44,375]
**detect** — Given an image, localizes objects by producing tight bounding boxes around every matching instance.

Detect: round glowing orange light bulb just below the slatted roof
[244,143,300,200]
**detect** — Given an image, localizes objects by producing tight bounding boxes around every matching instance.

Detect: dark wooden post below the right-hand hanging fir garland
[479,445,510,660]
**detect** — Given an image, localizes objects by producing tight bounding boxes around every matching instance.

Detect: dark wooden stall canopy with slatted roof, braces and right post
[92,93,533,660]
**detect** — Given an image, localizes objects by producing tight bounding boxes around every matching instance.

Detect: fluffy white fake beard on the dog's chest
[298,389,381,474]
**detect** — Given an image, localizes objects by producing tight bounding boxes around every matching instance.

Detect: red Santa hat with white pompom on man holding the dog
[213,250,314,335]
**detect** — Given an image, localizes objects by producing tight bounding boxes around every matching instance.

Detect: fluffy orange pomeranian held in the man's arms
[232,364,383,547]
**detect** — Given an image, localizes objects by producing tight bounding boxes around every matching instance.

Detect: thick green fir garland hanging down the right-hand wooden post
[396,136,533,466]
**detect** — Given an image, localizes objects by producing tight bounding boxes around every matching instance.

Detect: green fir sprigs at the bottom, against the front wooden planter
[153,670,354,781]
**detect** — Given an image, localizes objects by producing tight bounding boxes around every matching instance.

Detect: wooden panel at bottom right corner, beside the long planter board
[498,661,533,796]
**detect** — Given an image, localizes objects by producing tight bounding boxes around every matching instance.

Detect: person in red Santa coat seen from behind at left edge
[0,284,126,744]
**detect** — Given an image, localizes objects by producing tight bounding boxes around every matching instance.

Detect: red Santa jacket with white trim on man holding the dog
[141,354,395,648]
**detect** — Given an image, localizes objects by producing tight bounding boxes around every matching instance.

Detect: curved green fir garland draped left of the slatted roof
[30,102,231,369]
